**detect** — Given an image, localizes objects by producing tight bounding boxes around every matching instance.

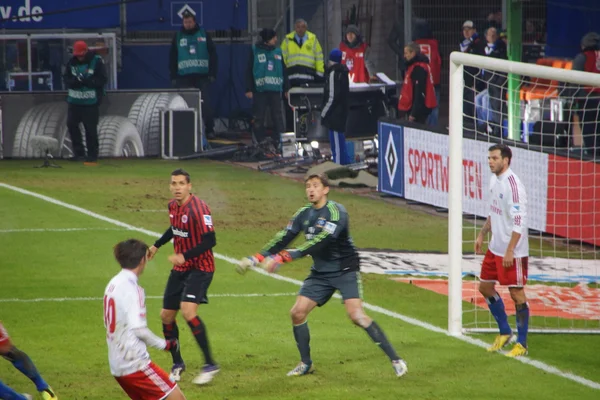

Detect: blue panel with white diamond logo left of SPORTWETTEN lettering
[378,122,404,197]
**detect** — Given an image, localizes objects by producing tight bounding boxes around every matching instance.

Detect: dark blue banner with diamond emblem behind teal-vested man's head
[127,0,248,31]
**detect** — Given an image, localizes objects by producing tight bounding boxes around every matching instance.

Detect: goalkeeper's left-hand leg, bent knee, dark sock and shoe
[287,296,317,376]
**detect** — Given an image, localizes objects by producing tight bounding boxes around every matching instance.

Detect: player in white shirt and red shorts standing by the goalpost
[475,144,529,357]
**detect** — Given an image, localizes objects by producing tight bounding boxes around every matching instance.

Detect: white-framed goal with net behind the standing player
[448,53,600,335]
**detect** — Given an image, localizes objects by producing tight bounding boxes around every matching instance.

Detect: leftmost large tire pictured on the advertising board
[11,102,67,158]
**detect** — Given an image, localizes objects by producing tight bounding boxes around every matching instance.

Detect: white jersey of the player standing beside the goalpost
[489,168,529,258]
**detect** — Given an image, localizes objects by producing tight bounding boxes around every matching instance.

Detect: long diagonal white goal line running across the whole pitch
[0,182,600,390]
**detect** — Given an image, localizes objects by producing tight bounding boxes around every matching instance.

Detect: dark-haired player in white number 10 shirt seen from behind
[104,239,185,400]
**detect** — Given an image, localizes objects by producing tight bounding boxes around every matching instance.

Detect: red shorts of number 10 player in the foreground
[115,362,177,400]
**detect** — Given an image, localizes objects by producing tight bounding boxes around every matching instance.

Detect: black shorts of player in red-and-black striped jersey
[163,269,214,310]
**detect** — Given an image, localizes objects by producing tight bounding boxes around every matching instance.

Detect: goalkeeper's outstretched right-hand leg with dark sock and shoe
[344,299,408,377]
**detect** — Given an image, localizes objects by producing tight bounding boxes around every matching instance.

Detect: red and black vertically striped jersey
[169,194,215,272]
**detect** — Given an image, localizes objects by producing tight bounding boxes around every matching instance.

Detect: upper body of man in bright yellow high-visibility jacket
[281,19,325,87]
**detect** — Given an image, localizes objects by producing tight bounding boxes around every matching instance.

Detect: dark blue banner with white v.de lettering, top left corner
[0,0,120,31]
